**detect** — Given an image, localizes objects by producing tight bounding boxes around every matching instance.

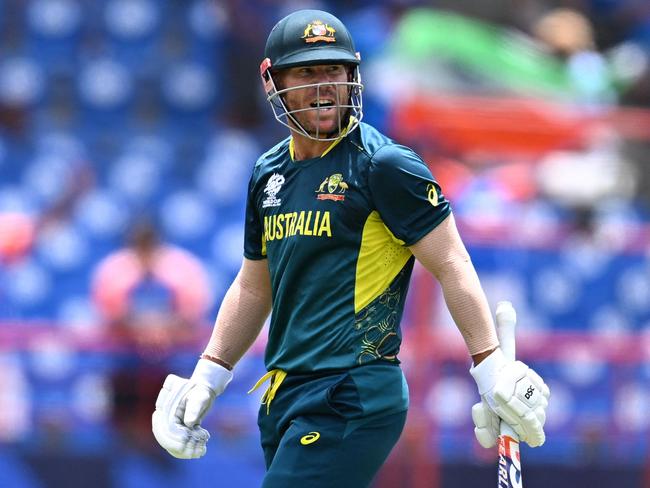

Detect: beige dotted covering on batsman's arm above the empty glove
[204,258,271,366]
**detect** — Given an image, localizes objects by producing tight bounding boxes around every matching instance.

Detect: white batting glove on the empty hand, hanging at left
[151,359,232,459]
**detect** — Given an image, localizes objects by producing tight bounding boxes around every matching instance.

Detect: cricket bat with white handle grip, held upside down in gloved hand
[496,302,523,488]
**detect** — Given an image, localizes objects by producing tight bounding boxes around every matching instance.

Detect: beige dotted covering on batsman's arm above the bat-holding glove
[410,214,499,355]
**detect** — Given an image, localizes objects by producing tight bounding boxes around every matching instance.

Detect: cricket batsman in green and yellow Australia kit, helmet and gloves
[153,10,549,488]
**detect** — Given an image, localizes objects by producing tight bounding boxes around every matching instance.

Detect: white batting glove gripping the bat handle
[470,348,550,447]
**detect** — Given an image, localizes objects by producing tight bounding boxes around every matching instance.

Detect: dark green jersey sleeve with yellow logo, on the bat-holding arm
[368,144,451,246]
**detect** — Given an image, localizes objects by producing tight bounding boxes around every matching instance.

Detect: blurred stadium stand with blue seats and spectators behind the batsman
[0,0,650,488]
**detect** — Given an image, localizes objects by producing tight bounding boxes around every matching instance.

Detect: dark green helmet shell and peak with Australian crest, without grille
[264,10,359,69]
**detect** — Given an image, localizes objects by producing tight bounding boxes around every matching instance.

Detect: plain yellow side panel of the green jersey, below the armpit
[354,210,412,313]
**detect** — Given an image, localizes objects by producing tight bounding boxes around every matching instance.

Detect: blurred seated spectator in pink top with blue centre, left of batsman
[92,222,210,451]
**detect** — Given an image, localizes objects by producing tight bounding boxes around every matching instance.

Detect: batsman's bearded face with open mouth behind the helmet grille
[279,64,350,136]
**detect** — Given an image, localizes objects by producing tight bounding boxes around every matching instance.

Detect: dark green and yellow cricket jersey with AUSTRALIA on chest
[244,123,451,373]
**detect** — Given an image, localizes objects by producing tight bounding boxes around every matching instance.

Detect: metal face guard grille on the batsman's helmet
[260,58,363,141]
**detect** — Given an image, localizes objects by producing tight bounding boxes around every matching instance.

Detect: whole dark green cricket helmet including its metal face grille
[260,10,363,141]
